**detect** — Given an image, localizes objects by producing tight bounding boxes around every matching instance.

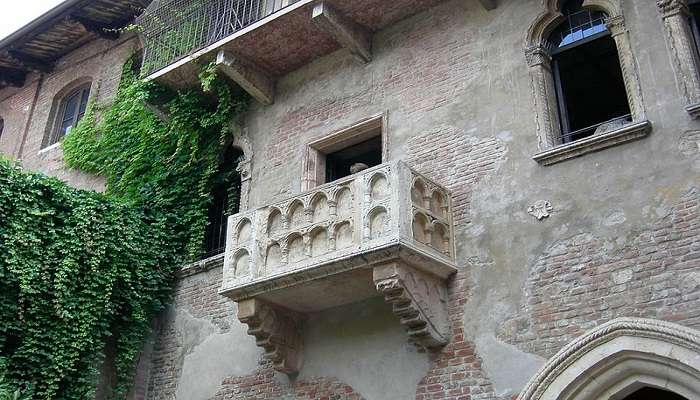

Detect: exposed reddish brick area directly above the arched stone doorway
[501,189,700,357]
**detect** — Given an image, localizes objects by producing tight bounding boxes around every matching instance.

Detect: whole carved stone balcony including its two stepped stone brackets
[220,162,456,373]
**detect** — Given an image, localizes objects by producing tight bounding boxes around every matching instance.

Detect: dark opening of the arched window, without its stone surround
[549,0,631,143]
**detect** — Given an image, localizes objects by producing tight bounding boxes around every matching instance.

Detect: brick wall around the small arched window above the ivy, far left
[0,34,139,190]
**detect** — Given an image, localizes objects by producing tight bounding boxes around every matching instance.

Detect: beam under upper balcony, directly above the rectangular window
[311,1,372,62]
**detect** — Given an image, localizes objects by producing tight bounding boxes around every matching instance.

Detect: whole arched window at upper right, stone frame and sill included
[525,0,651,165]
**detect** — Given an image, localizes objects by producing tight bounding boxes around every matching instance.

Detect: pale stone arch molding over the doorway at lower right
[518,318,700,400]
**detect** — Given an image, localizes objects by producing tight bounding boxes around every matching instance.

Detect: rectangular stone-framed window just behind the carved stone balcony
[302,114,388,190]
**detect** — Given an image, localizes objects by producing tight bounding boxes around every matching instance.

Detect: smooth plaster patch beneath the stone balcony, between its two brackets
[299,299,430,400]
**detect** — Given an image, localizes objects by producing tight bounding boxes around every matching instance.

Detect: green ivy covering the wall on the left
[0,57,249,399]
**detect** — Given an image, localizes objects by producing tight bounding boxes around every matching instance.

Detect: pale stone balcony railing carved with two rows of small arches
[221,162,454,300]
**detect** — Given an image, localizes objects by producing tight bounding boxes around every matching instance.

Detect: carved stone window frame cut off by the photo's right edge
[656,0,700,119]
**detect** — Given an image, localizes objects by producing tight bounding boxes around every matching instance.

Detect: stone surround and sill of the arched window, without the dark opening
[525,0,651,166]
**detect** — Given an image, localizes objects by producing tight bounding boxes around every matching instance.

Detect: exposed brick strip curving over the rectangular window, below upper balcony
[262,8,483,206]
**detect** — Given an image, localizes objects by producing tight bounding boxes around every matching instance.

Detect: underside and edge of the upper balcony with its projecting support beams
[143,0,496,104]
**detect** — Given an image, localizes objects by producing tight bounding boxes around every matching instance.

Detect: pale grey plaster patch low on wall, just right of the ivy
[175,309,261,400]
